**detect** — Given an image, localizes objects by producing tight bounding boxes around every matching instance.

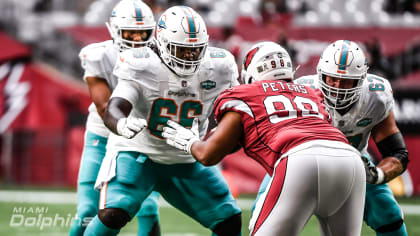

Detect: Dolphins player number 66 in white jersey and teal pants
[86,6,241,236]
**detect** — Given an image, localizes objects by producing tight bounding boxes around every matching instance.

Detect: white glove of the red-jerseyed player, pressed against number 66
[162,118,200,154]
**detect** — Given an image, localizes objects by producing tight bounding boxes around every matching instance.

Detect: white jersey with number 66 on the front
[107,47,238,164]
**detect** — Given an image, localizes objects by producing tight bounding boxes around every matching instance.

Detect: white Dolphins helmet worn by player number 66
[156,6,209,76]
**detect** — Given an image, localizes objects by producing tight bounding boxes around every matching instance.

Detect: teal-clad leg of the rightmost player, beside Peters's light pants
[364,154,407,236]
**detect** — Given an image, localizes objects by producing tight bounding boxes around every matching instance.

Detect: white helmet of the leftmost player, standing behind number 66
[105,0,156,51]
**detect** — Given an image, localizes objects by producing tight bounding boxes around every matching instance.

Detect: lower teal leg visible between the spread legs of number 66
[136,192,160,236]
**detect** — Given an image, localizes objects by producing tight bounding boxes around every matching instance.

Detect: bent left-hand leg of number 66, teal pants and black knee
[85,152,154,235]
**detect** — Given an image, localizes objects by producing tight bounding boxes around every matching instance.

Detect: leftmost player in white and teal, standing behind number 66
[70,0,160,236]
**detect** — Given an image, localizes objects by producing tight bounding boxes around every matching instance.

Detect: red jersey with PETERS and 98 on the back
[214,80,348,175]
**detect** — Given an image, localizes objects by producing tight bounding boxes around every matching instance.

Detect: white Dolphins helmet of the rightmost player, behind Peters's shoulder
[317,40,368,109]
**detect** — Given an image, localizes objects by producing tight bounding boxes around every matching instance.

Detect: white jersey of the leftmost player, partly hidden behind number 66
[79,40,119,137]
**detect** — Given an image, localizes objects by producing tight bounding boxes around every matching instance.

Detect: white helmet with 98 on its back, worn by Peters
[241,41,293,84]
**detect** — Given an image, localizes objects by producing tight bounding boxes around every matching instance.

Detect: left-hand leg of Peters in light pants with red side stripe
[249,155,317,236]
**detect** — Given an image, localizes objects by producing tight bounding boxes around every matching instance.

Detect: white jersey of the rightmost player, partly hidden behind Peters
[294,74,394,152]
